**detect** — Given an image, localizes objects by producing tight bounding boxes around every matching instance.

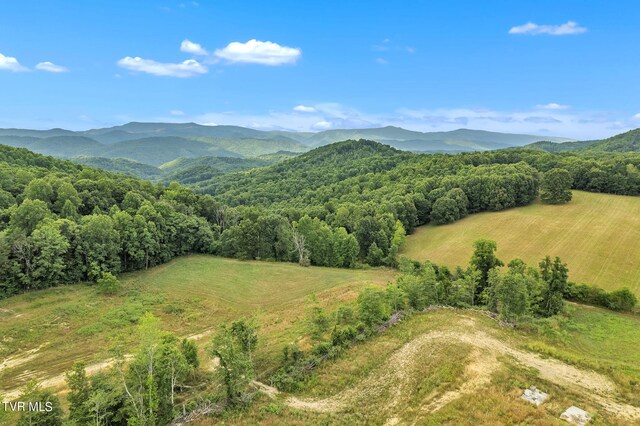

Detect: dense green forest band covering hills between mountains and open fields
[0,136,640,296]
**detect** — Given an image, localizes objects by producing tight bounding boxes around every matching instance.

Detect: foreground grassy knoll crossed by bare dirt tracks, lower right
[215,306,640,425]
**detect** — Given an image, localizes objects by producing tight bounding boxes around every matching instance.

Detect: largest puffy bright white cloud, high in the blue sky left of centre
[214,39,302,65]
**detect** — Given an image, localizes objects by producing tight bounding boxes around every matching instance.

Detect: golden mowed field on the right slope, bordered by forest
[403,191,640,295]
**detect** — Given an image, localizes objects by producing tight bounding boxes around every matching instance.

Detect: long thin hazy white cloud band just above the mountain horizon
[174,103,640,140]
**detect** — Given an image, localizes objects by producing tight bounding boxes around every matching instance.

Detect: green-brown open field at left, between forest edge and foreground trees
[0,255,395,400]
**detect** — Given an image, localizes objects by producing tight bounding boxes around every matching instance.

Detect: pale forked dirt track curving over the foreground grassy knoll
[260,332,640,425]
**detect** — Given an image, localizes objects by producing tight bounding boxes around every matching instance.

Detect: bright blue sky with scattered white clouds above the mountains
[0,0,640,139]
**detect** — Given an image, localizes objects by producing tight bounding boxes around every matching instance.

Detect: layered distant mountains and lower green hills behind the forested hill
[0,122,580,184]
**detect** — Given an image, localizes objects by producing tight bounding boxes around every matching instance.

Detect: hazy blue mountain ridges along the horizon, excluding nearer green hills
[0,122,570,166]
